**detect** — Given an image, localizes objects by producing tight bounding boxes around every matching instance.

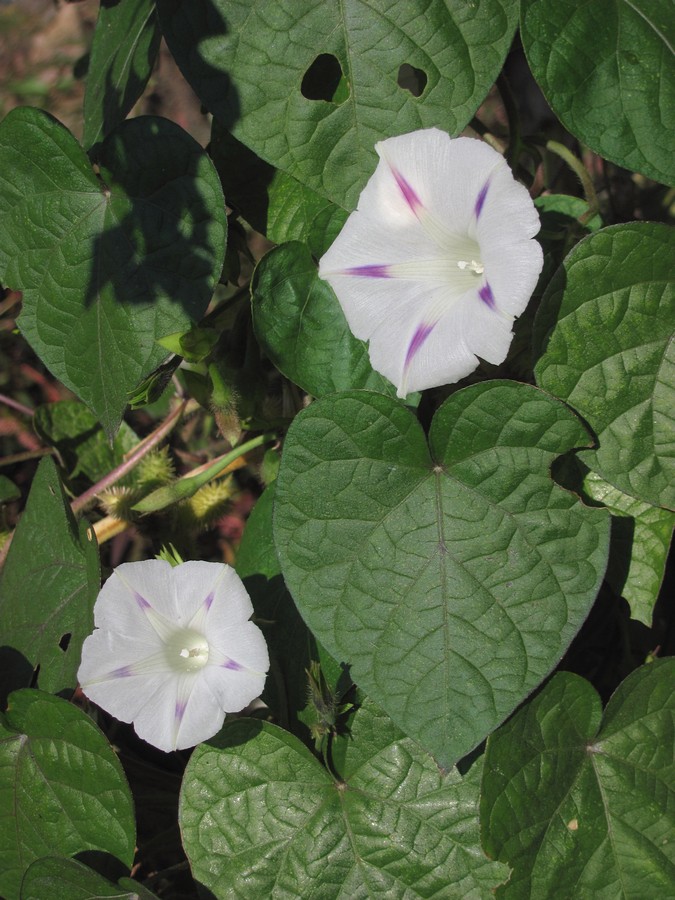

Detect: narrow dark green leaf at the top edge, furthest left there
[82,0,161,147]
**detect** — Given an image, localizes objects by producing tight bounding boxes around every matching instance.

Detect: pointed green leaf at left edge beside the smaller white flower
[0,458,101,699]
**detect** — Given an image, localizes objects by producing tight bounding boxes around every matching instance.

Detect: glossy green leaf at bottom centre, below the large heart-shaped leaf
[180,705,508,900]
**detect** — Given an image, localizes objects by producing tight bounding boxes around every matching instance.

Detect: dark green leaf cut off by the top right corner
[520,0,675,184]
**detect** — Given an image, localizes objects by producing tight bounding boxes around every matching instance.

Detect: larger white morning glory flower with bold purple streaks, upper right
[319,128,543,397]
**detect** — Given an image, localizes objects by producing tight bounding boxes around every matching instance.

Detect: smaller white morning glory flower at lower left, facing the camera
[77,559,269,751]
